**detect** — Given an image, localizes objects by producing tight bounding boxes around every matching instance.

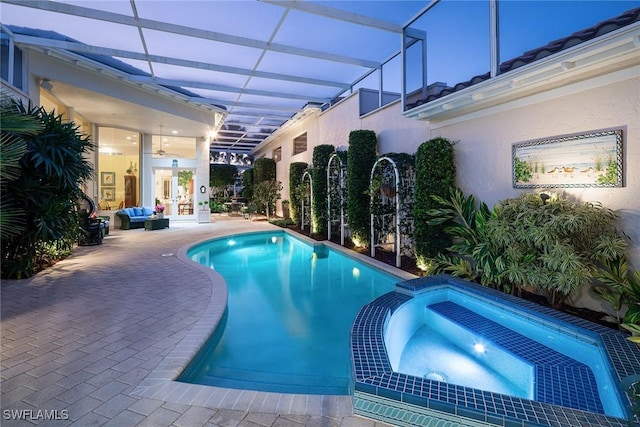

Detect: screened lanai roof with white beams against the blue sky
[0,0,430,152]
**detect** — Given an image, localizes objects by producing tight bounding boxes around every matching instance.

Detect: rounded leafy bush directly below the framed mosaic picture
[486,193,627,307]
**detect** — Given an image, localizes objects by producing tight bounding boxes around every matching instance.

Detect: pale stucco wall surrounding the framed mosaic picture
[433,77,640,269]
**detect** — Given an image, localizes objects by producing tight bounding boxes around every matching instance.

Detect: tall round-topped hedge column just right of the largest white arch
[413,138,456,259]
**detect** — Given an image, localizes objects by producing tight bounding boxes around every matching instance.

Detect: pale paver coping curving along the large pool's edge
[131,228,416,417]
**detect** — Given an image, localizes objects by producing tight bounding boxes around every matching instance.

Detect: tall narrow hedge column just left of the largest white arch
[347,130,377,245]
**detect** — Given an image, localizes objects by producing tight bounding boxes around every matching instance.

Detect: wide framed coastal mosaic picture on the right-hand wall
[512,129,623,188]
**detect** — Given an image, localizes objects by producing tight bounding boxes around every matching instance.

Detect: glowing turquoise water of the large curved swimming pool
[178,232,400,394]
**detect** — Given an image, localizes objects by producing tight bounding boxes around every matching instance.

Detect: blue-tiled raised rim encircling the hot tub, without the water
[352,275,640,427]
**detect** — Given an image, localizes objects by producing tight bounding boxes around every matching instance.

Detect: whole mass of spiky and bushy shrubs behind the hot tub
[429,190,624,307]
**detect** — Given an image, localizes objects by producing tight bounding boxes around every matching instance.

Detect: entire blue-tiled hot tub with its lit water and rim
[352,276,640,426]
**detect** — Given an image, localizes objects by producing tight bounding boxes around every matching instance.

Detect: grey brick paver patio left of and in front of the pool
[0,217,392,427]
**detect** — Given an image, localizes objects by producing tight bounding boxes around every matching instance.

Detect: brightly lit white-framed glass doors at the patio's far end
[154,168,196,220]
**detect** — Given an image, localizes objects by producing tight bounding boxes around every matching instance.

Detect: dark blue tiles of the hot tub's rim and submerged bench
[352,275,640,427]
